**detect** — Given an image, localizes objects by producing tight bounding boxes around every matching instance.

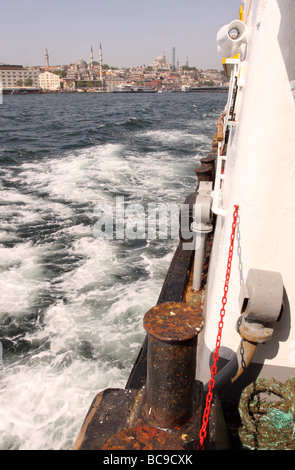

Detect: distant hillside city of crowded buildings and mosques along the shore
[0,51,228,93]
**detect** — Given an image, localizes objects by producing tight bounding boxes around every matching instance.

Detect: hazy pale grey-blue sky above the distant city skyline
[0,0,241,69]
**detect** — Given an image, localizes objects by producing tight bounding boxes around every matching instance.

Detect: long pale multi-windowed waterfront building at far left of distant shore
[0,64,40,90]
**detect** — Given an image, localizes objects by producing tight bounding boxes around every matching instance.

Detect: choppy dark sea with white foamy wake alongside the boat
[0,93,226,450]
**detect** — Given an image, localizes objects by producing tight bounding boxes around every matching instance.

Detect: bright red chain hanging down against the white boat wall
[198,206,239,450]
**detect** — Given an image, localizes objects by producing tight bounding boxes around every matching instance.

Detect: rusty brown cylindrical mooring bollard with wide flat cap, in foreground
[143,302,204,428]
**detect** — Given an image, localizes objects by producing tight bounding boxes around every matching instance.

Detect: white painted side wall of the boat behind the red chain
[197,0,295,383]
